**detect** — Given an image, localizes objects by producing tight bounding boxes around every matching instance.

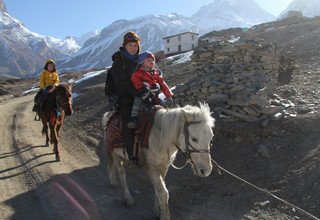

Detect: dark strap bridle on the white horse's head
[170,121,210,169]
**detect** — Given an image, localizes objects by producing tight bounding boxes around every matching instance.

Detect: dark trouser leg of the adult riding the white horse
[119,96,135,158]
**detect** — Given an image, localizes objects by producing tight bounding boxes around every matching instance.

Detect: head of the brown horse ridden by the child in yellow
[56,83,73,116]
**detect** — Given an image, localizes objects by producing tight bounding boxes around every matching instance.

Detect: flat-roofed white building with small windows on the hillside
[163,31,199,55]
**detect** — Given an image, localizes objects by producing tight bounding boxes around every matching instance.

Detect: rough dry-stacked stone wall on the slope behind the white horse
[174,39,296,122]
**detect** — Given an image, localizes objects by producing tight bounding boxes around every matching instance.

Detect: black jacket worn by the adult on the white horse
[111,48,139,98]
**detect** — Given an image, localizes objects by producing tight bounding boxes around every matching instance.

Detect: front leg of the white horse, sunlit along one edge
[148,169,170,220]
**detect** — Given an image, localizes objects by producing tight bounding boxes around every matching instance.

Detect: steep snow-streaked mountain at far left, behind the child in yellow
[0,0,80,79]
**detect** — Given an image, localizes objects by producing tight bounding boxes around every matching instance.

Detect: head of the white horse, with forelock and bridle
[179,104,214,177]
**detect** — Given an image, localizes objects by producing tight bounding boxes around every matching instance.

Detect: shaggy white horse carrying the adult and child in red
[102,103,215,220]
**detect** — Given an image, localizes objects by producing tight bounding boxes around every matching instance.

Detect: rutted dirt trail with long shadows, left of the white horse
[0,96,162,219]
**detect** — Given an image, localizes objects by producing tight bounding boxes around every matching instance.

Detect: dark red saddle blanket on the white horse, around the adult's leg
[105,106,161,155]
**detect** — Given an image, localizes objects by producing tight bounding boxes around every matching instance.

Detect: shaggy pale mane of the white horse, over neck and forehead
[152,103,215,152]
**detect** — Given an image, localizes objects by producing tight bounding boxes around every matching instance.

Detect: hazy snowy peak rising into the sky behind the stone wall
[191,0,274,34]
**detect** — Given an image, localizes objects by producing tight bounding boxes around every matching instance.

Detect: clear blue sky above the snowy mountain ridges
[4,0,293,38]
